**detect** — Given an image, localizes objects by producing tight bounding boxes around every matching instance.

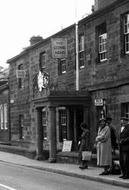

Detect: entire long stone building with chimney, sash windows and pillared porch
[8,0,129,162]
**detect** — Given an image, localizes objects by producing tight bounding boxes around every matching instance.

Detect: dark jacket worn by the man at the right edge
[119,124,129,152]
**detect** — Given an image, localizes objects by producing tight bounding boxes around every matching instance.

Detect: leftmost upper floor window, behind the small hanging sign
[18,64,24,89]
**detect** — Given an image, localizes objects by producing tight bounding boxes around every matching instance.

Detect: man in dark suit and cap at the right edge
[119,117,129,179]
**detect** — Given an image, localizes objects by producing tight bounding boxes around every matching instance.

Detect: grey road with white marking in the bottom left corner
[0,162,127,190]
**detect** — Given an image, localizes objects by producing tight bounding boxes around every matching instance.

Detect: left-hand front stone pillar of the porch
[36,108,43,160]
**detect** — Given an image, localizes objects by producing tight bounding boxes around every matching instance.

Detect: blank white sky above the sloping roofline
[0,0,94,68]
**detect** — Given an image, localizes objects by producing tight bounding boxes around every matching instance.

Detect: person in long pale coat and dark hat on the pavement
[96,119,112,175]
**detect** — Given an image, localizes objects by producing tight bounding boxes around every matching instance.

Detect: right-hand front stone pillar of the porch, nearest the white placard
[49,106,57,163]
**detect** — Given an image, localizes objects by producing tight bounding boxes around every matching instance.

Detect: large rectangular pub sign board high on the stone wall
[51,38,67,59]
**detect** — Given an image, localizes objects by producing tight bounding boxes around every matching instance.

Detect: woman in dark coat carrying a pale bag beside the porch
[79,123,90,169]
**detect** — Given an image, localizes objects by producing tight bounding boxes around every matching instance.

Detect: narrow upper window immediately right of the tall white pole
[79,34,85,69]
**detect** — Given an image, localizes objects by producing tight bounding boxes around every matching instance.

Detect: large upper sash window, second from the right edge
[96,23,107,62]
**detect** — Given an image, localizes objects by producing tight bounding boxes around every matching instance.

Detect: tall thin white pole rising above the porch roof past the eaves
[75,0,79,91]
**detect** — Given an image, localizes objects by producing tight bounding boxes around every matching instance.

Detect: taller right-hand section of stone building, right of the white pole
[79,0,129,139]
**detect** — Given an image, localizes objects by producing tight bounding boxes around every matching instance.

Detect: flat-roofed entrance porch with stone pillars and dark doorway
[33,92,91,162]
